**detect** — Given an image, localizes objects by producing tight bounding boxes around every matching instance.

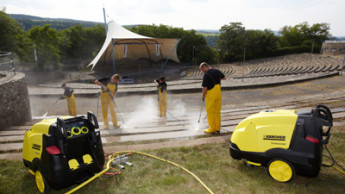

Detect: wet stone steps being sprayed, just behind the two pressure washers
[0,91,345,159]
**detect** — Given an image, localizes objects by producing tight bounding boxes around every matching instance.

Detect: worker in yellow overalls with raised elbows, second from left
[95,74,121,128]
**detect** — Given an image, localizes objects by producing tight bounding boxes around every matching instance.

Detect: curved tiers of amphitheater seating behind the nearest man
[182,54,342,80]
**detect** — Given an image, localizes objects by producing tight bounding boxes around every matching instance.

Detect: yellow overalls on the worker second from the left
[101,83,119,128]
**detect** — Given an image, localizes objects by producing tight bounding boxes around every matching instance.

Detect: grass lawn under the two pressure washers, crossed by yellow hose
[0,126,345,194]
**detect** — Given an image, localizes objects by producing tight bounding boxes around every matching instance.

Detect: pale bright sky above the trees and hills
[0,0,345,36]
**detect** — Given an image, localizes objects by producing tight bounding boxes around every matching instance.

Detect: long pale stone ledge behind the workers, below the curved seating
[29,72,339,96]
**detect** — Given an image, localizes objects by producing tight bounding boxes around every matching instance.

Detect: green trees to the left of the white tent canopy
[0,11,105,71]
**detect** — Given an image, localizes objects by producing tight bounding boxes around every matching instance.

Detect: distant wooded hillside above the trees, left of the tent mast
[9,14,103,31]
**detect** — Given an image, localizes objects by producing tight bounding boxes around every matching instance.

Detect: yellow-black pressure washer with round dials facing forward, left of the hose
[22,112,105,193]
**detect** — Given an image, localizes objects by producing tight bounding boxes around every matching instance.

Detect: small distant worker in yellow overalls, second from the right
[154,77,168,117]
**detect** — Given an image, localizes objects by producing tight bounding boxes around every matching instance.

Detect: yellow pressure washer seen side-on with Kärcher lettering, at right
[230,105,333,182]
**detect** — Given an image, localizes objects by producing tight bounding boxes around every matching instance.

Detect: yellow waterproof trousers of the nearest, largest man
[205,84,222,133]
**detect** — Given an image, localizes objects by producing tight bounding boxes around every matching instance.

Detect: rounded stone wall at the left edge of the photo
[0,71,31,130]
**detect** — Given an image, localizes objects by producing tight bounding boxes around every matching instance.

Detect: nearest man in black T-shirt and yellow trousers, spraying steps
[199,62,226,133]
